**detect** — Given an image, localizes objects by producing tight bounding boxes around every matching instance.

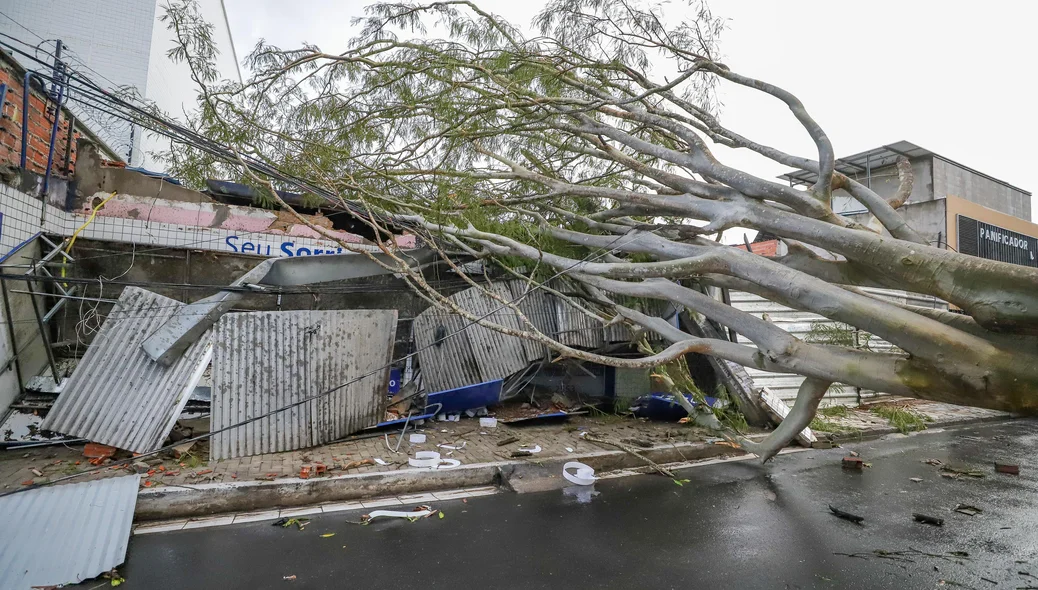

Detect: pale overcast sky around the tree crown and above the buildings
[224,0,1038,213]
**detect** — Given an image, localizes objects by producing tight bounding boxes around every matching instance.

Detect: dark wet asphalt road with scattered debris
[103,421,1038,589]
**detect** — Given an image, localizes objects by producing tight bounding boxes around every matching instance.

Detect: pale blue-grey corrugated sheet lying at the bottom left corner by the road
[0,476,140,590]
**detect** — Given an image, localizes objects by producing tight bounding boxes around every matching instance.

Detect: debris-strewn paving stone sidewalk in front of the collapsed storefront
[0,400,1010,490]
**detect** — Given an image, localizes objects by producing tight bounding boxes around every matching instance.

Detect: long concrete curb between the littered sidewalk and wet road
[134,417,1010,521]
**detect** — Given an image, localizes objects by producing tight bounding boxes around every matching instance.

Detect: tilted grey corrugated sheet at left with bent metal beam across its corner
[43,287,213,453]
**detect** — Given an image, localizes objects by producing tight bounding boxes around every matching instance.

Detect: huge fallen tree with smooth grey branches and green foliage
[159,0,1038,460]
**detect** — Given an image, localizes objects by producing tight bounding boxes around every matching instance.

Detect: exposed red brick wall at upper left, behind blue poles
[0,66,79,177]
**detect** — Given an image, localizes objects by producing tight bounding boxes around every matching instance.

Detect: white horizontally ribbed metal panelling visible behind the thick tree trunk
[731,289,948,405]
